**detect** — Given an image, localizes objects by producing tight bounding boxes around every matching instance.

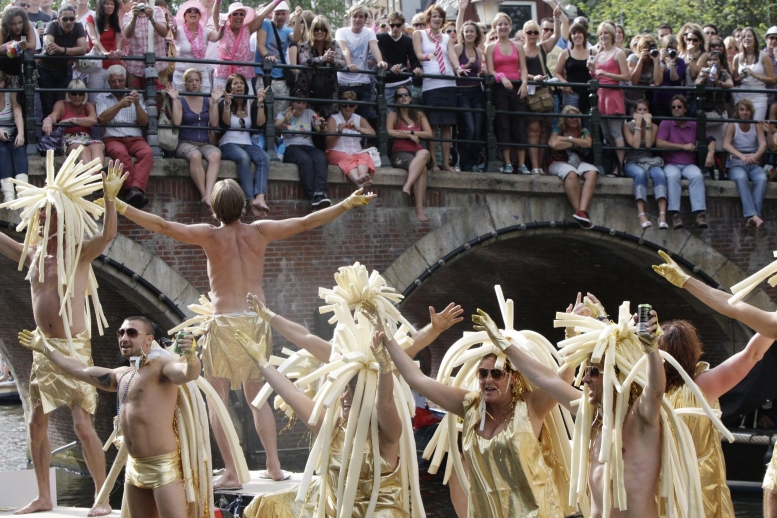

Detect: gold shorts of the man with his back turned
[202,313,272,390]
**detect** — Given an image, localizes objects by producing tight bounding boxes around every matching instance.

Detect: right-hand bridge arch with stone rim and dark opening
[384,198,776,376]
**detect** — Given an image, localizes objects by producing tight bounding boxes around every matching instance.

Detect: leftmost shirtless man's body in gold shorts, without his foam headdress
[0,169,124,516]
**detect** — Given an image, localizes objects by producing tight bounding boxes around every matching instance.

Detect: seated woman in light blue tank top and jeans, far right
[723,99,768,228]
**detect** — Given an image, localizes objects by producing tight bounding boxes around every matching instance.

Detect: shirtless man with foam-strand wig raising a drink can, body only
[472,310,666,518]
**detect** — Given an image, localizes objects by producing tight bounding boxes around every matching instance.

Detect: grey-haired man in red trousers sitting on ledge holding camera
[97,65,154,209]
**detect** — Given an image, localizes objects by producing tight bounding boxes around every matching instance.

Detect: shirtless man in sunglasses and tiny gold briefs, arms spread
[19,317,202,518]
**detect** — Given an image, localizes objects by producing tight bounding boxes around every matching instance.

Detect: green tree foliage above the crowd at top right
[580,0,777,37]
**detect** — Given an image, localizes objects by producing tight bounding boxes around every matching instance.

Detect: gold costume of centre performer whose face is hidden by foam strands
[243,425,408,518]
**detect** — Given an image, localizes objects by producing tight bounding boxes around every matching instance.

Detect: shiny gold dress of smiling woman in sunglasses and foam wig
[462,391,564,518]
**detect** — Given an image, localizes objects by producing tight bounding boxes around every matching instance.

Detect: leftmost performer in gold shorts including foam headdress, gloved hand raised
[0,161,126,516]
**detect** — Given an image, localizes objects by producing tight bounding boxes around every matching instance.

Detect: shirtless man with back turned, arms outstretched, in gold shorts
[103,180,375,489]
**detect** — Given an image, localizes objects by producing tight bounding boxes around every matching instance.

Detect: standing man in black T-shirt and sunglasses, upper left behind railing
[38,4,87,124]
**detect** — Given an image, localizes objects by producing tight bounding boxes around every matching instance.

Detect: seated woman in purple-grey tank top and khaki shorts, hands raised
[167,72,221,207]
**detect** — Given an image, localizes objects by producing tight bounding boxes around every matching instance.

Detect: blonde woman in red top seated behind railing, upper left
[41,79,105,164]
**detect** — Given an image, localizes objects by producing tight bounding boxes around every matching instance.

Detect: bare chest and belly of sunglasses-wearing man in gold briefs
[116,357,182,458]
